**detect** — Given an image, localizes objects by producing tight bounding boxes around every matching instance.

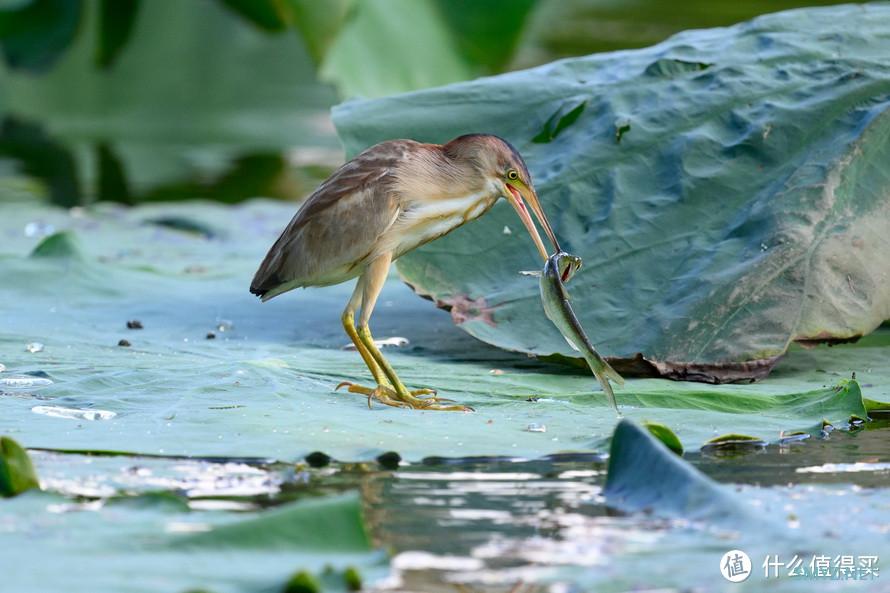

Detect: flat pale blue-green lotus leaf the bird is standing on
[0,201,890,461]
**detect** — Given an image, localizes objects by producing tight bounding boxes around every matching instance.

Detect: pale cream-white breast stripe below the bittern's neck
[386,192,498,257]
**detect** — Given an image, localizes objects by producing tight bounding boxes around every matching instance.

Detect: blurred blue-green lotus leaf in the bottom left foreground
[0,493,387,593]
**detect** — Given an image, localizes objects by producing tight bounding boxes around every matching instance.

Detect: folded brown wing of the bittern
[250,140,413,299]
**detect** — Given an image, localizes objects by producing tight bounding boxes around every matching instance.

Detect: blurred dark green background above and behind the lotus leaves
[0,0,860,207]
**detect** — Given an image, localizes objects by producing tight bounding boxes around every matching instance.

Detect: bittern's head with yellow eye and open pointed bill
[444,134,562,261]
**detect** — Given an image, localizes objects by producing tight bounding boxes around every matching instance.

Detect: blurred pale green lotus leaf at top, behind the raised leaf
[312,0,534,97]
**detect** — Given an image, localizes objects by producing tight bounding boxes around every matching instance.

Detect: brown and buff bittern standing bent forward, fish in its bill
[250,134,560,410]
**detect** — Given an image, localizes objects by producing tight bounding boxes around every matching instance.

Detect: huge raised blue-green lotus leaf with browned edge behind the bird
[334,4,890,381]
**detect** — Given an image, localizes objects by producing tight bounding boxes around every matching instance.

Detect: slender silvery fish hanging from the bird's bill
[523,251,624,416]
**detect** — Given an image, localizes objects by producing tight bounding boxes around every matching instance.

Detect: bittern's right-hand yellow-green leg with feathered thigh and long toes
[350,253,468,411]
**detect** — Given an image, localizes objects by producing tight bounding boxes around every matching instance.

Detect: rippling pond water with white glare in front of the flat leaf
[20,421,890,592]
